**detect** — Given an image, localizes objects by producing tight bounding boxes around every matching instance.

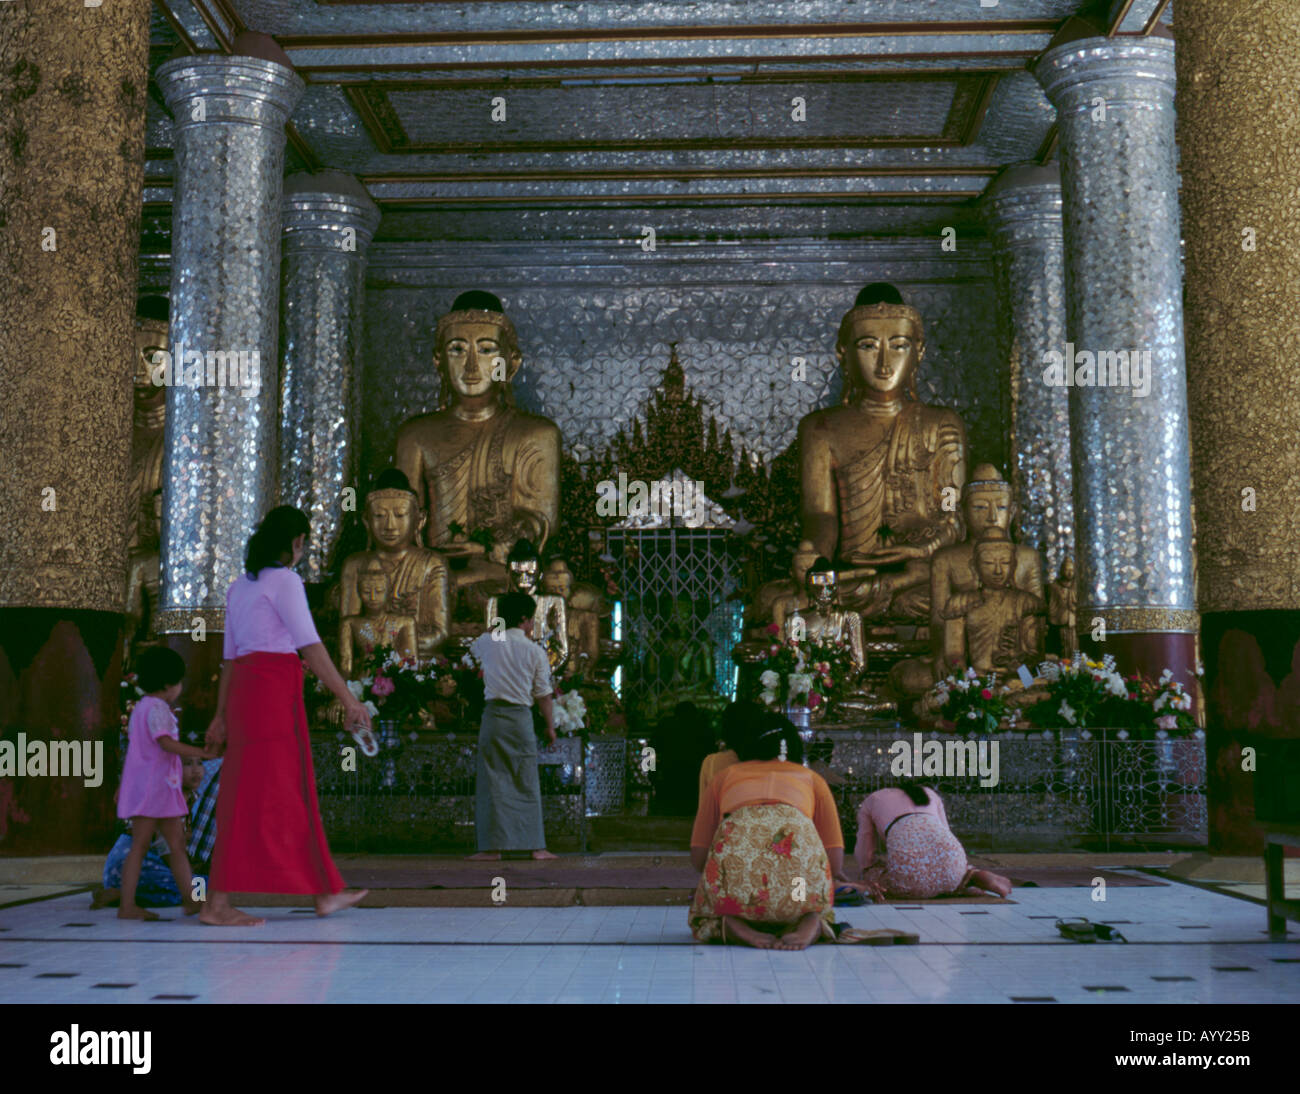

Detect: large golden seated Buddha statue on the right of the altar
[800,285,967,620]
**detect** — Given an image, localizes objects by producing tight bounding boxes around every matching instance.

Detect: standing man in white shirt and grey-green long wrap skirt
[469,592,555,859]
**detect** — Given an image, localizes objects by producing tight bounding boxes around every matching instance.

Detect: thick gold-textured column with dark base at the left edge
[0,0,150,854]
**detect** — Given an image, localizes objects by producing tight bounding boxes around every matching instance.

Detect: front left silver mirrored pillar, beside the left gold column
[157,43,303,634]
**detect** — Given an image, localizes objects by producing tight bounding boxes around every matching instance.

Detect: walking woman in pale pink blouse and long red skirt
[199,505,371,926]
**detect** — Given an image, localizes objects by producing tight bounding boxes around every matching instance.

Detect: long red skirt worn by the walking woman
[209,652,345,894]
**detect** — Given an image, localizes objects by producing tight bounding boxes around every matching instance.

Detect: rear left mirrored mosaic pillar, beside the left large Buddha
[280,172,380,582]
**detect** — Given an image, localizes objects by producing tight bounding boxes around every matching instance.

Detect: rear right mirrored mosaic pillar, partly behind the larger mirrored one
[984,164,1074,581]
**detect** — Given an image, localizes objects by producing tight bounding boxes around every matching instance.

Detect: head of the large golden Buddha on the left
[434,290,524,408]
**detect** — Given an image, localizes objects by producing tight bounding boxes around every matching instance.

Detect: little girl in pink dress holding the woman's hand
[117,647,211,920]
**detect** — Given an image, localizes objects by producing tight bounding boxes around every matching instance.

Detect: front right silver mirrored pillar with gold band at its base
[1035,38,1197,687]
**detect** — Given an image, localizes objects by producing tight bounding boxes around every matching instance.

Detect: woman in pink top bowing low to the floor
[853,780,1011,902]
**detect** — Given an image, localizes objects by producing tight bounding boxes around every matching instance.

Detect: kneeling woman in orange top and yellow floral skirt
[690,711,845,950]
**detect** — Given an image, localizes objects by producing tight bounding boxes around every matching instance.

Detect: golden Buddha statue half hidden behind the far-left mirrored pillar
[126,296,169,644]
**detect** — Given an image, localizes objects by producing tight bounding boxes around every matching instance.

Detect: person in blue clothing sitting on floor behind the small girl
[90,756,221,908]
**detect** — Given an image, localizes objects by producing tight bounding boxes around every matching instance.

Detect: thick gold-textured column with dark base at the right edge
[1175,0,1300,854]
